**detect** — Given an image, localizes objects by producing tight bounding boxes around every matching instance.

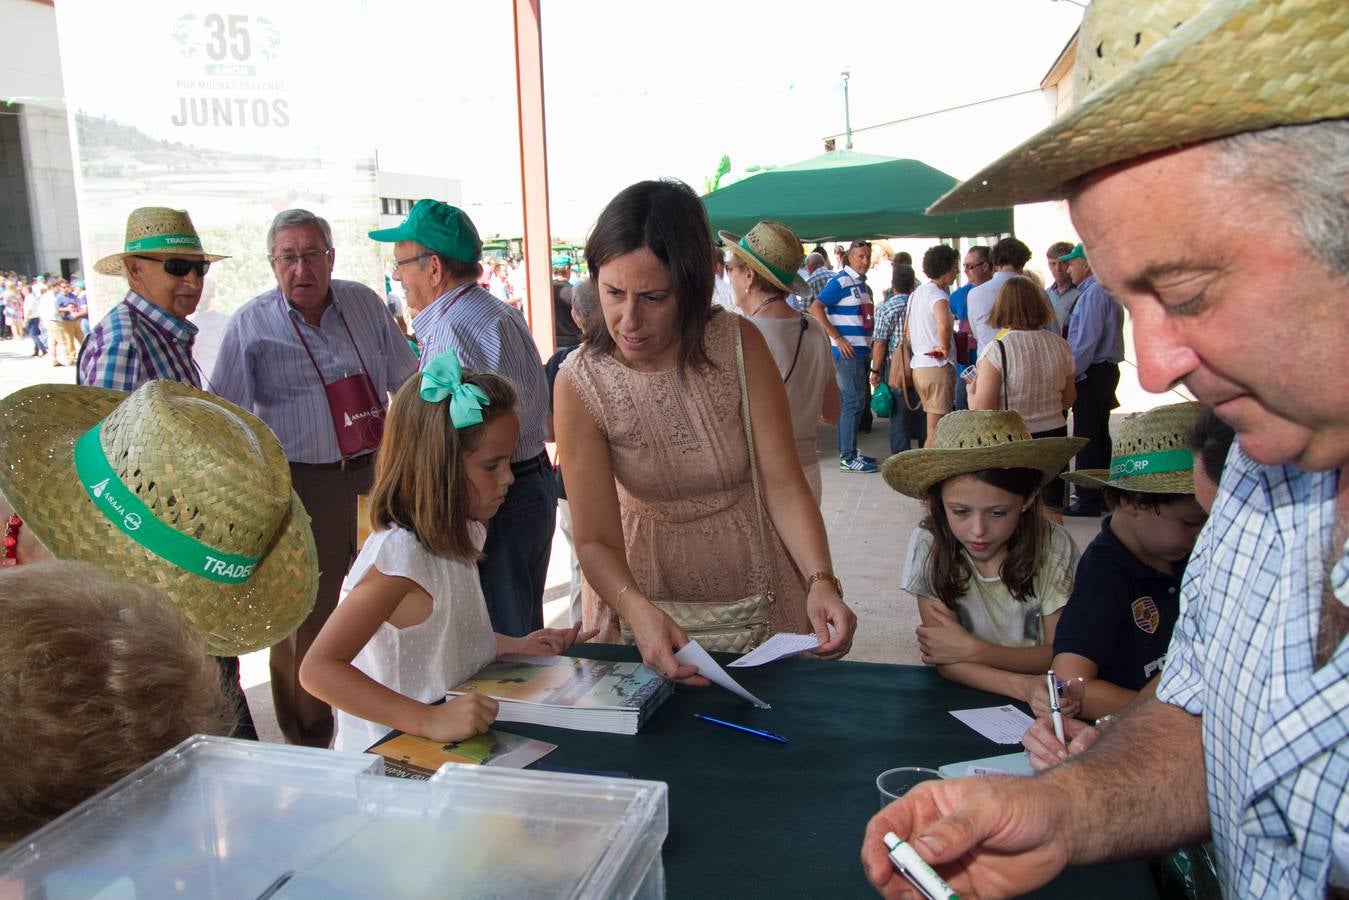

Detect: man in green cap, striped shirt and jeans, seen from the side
[370,200,555,637]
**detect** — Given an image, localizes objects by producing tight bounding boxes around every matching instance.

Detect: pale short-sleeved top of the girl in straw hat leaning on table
[902,522,1078,646]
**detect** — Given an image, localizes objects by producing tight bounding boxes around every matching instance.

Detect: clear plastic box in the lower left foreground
[0,735,668,900]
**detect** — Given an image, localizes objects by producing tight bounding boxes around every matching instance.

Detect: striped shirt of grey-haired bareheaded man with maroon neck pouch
[210,279,417,463]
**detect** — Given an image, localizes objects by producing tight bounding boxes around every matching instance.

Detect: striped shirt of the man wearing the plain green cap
[411,285,549,463]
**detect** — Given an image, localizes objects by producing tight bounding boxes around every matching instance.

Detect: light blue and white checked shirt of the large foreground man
[1157,449,1349,897]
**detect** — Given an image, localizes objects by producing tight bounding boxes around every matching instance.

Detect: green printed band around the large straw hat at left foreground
[74,422,262,584]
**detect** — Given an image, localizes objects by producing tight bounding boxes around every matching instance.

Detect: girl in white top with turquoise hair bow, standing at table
[299,349,594,752]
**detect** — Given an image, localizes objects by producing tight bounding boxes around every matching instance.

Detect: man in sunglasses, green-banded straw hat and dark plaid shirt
[78,206,229,391]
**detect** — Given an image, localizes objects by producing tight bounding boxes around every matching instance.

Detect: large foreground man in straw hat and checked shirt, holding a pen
[862,0,1349,897]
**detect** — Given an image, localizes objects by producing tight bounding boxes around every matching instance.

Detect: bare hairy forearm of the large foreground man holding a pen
[1041,699,1209,865]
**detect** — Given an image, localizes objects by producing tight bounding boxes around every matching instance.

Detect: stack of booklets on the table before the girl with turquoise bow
[448,654,672,734]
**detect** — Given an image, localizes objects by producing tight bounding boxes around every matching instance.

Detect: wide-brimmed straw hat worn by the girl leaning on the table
[882,409,1087,499]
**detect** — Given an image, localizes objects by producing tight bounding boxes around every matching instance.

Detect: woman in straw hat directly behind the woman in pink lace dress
[718,220,839,503]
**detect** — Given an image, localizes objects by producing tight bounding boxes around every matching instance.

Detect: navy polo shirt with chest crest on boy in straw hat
[1054,517,1188,691]
